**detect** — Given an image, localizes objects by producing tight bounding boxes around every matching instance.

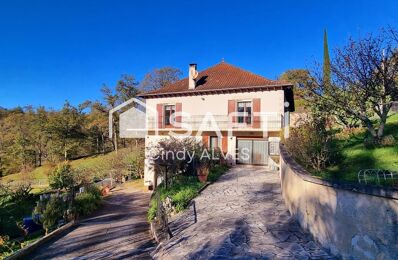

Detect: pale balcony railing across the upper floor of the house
[147,115,284,131]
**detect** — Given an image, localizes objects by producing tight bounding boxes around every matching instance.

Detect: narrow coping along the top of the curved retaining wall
[280,145,398,200]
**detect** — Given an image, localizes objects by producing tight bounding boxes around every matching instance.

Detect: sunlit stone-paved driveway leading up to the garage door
[153,166,332,259]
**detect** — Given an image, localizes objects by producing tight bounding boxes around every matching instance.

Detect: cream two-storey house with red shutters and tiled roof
[140,62,294,189]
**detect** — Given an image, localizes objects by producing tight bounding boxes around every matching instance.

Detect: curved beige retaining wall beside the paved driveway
[280,146,398,259]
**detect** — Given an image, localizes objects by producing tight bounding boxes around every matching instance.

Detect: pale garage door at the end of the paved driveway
[238,139,268,165]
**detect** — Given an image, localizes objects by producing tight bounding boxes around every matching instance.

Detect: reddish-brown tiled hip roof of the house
[140,62,292,98]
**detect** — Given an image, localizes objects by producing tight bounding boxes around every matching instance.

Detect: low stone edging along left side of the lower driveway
[5,221,79,260]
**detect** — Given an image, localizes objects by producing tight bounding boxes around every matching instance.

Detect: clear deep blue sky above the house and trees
[0,0,398,108]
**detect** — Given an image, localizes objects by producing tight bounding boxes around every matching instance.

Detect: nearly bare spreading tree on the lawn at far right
[307,28,398,143]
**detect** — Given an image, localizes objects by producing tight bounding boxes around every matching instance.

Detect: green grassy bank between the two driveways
[148,165,228,221]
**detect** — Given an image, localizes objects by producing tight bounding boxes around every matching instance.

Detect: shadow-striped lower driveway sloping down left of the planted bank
[30,184,155,259]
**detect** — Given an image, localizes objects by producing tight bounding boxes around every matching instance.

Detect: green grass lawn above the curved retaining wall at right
[319,114,398,182]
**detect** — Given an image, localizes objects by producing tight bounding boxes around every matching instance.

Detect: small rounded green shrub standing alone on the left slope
[49,162,76,190]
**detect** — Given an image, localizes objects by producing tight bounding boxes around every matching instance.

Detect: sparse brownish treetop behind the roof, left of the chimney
[142,67,182,91]
